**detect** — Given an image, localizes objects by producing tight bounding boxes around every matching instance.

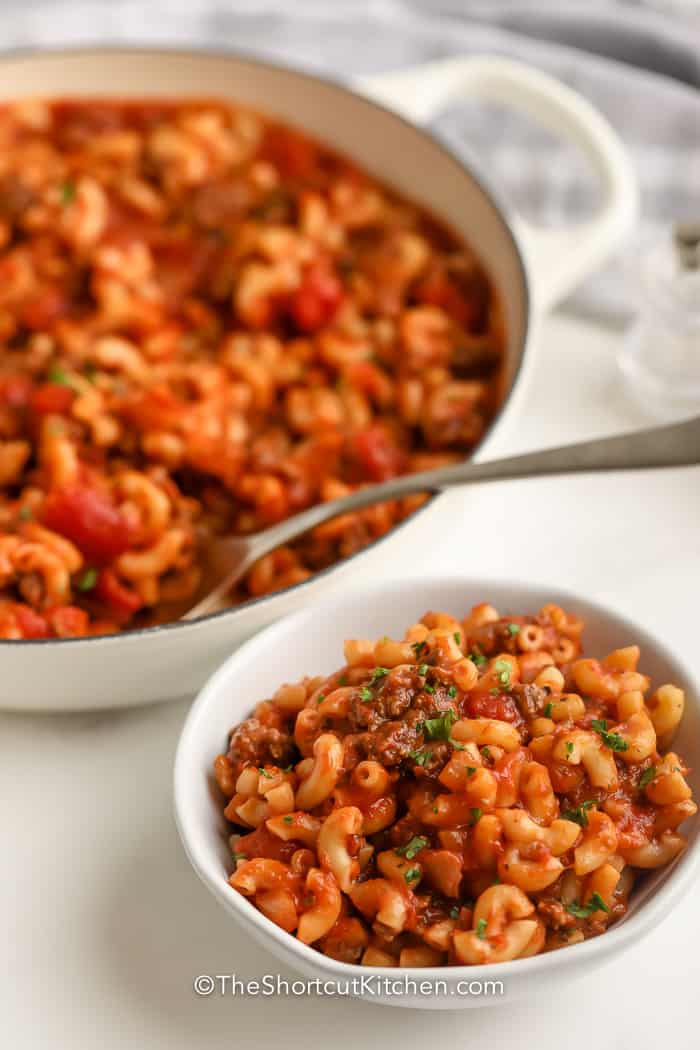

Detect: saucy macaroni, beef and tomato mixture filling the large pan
[0,99,505,634]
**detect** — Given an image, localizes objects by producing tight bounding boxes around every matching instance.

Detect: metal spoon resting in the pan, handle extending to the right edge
[182,417,700,620]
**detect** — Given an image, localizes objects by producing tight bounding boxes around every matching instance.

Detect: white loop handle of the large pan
[355,57,639,310]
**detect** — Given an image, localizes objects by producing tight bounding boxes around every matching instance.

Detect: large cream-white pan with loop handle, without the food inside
[0,49,637,711]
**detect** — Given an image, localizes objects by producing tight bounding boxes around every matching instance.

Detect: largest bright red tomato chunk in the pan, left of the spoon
[43,485,130,565]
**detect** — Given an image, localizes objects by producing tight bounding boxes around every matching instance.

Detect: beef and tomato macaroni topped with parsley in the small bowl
[215,605,697,967]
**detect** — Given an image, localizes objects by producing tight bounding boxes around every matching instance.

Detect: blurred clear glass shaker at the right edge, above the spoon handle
[618,222,700,419]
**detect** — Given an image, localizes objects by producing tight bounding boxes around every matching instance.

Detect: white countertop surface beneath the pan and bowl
[0,315,700,1050]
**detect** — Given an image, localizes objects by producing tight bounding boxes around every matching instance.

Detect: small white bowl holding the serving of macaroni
[174,579,700,1009]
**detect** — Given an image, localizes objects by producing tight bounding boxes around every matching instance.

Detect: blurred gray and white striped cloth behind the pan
[5,0,700,320]
